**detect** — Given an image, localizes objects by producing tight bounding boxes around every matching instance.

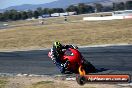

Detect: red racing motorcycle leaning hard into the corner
[48,48,96,75]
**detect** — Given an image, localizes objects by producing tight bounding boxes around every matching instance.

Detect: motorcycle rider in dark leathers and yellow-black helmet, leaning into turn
[51,41,77,73]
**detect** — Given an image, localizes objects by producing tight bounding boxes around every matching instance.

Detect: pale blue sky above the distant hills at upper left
[0,0,57,9]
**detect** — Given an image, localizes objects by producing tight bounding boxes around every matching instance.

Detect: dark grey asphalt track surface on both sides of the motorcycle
[0,45,132,75]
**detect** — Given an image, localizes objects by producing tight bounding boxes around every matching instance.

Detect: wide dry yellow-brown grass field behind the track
[0,16,132,49]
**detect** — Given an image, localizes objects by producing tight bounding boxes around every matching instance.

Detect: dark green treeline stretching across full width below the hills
[0,1,132,21]
